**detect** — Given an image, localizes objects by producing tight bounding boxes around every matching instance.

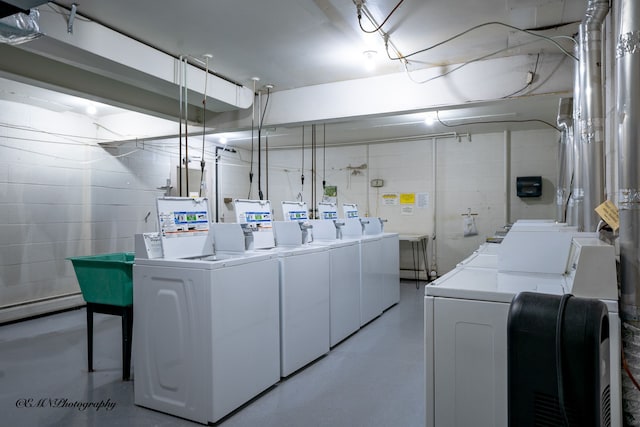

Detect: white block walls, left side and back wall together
[0,101,558,318]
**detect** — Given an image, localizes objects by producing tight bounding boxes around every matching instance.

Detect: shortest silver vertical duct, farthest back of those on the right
[556,98,573,222]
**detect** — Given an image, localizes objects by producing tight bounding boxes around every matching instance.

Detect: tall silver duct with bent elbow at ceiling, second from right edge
[580,0,609,231]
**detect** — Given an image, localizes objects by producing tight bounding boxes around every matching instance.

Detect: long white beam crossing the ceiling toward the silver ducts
[208,54,574,129]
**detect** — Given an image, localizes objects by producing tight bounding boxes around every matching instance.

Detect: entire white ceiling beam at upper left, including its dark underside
[0,4,253,120]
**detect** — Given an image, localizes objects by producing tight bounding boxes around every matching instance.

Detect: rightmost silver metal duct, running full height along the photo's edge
[616,0,640,426]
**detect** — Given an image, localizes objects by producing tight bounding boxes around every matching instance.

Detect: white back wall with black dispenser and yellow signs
[253,130,558,274]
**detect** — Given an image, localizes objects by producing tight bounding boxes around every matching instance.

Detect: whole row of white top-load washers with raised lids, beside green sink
[133,198,399,424]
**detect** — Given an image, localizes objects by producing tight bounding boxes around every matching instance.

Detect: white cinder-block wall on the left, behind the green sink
[0,101,210,314]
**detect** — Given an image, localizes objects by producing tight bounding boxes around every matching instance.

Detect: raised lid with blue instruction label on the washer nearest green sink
[156,197,213,259]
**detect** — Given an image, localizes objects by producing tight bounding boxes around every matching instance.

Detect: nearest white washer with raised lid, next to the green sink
[133,199,280,424]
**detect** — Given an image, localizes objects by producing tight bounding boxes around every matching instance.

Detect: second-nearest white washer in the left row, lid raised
[235,200,330,377]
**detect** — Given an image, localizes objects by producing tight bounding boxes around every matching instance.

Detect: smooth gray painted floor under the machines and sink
[0,280,425,427]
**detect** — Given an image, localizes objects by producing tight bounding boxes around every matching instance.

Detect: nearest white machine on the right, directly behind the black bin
[424,232,621,427]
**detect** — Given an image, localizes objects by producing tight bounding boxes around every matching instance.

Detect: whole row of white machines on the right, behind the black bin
[424,222,622,427]
